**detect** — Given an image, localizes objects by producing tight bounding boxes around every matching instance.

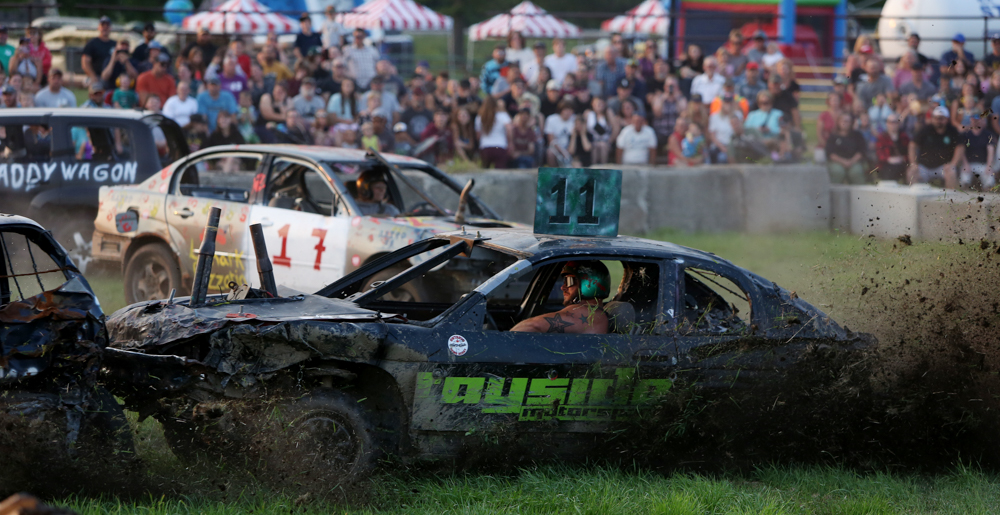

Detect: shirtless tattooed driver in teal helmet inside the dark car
[511,261,611,334]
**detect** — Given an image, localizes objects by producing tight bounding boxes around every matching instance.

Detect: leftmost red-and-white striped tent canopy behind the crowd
[181,0,299,34]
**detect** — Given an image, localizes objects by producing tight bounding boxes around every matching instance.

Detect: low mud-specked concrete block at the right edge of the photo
[918,191,996,242]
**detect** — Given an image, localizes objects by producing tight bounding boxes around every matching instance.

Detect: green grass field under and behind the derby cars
[57,232,1000,514]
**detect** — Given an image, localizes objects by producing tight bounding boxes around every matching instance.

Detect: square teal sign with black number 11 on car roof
[535,168,622,237]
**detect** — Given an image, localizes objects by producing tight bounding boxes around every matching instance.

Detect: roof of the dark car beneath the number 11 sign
[442,228,731,265]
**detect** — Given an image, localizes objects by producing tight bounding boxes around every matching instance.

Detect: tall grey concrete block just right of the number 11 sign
[640,166,745,232]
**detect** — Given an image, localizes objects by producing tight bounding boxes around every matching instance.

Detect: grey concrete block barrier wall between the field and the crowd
[423,165,1000,241]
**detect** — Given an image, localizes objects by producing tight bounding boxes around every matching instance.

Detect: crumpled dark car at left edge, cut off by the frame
[0,214,132,493]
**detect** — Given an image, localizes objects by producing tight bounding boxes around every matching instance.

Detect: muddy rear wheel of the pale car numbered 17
[125,243,182,304]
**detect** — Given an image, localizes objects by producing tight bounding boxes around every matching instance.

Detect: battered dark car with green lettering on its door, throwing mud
[99,229,872,480]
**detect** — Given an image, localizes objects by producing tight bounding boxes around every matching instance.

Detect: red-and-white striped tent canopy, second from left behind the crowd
[337,0,452,30]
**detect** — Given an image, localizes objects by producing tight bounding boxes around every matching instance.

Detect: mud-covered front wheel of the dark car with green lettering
[267,390,383,487]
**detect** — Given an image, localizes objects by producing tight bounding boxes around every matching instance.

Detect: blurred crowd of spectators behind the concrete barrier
[0,15,1000,188]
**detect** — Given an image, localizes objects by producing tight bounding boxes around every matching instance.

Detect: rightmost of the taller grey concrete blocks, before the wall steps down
[739,165,830,234]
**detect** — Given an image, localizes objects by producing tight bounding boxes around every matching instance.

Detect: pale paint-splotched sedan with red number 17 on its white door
[93,145,509,302]
